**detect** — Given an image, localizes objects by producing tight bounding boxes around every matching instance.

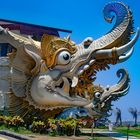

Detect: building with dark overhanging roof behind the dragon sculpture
[0,19,72,110]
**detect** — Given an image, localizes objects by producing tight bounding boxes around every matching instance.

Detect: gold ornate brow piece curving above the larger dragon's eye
[41,34,76,68]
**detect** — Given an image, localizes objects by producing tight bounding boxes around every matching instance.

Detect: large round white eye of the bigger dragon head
[58,51,71,64]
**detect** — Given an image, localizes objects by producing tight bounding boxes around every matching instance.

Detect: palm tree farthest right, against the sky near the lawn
[128,107,140,126]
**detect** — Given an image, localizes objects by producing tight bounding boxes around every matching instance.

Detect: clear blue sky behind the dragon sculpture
[0,0,140,120]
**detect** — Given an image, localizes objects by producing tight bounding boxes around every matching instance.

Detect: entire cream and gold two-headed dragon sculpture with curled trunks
[0,2,139,118]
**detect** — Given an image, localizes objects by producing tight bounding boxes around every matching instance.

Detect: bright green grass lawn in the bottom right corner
[115,127,140,138]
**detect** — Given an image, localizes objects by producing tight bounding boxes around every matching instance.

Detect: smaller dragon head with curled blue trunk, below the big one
[86,69,130,117]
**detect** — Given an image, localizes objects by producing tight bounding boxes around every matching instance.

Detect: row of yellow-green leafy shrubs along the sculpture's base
[0,116,82,136]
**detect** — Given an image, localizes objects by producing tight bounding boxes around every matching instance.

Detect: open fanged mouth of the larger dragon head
[55,59,103,103]
